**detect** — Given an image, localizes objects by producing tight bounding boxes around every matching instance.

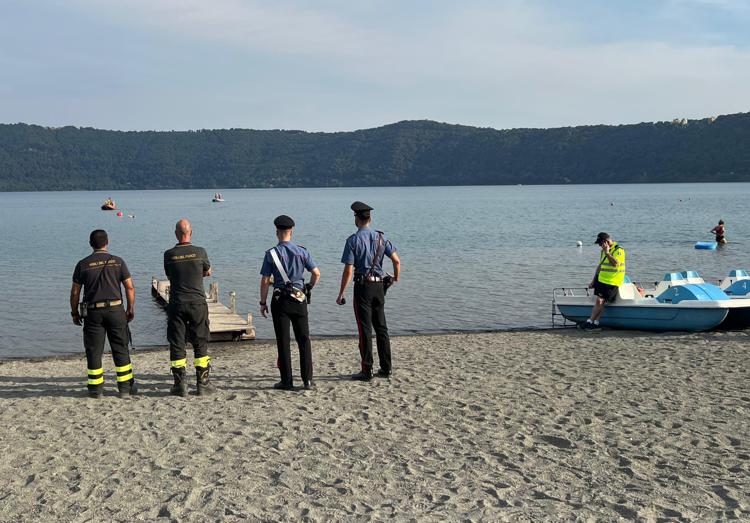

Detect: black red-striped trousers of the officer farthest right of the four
[354,281,391,374]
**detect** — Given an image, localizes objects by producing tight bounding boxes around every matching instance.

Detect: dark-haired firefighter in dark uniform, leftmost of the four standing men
[70,229,136,398]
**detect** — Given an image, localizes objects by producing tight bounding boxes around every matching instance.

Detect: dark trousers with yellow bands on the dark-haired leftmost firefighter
[83,305,132,386]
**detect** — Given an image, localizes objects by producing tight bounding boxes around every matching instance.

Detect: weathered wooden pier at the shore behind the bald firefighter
[151,277,255,341]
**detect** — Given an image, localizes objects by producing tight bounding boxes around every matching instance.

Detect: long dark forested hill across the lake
[0,113,750,191]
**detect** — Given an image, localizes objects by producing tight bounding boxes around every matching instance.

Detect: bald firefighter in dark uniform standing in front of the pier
[164,219,215,397]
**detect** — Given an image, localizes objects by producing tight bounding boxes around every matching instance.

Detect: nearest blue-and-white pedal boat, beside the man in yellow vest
[553,273,744,332]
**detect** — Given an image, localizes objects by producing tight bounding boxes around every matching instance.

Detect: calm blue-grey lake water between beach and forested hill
[0,184,750,358]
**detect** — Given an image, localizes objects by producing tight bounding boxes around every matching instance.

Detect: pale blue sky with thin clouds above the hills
[0,0,750,132]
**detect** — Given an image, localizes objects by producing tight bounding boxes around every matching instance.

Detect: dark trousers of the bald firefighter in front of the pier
[167,301,209,367]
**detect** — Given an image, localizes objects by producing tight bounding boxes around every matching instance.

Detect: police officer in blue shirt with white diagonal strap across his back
[260,215,320,390]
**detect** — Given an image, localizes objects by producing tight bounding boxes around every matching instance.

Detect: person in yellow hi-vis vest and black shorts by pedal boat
[578,232,625,330]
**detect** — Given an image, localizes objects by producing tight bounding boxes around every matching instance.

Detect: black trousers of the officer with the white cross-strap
[271,292,312,386]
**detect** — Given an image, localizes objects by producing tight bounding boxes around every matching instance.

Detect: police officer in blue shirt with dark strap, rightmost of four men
[336,202,401,381]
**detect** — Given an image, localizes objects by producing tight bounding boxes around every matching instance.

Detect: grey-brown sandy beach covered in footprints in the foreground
[0,330,750,522]
